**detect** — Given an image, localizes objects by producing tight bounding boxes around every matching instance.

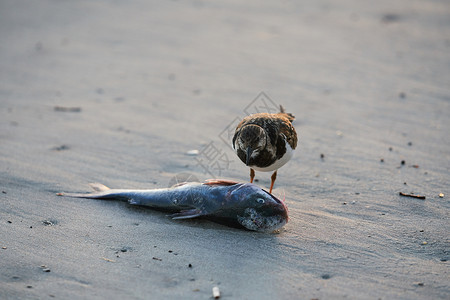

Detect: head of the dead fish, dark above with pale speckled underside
[232,183,288,232]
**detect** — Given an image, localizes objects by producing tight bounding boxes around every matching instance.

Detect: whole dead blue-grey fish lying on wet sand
[58,180,288,232]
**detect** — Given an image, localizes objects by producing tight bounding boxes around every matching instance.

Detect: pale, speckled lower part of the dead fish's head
[237,207,288,232]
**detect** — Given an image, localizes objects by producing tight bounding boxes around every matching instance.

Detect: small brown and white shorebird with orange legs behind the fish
[233,105,297,193]
